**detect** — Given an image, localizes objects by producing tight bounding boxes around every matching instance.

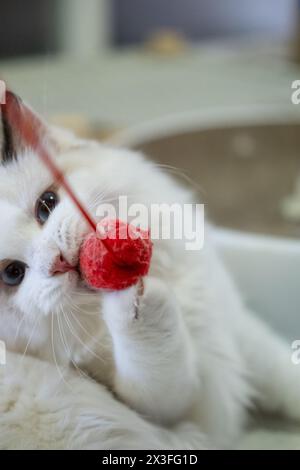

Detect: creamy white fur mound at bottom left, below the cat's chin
[0,353,207,450]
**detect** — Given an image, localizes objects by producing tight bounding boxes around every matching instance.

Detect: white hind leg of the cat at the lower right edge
[238,313,300,420]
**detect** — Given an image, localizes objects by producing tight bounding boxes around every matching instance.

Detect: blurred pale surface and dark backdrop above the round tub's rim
[0,0,300,127]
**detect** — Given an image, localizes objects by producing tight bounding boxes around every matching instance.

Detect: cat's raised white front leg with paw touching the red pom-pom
[103,277,197,423]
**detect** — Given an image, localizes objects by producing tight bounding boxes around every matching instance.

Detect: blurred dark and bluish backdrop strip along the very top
[0,0,297,57]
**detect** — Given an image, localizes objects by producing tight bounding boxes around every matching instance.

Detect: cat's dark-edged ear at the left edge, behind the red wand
[0,91,49,163]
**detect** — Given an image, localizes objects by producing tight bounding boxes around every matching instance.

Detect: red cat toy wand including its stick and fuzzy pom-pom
[1,92,152,290]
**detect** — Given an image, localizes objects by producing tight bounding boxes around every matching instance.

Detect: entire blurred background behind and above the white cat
[0,0,300,339]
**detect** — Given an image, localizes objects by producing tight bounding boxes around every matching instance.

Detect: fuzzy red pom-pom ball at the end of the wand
[80,219,152,290]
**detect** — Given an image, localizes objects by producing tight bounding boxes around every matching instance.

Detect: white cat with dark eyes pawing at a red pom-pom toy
[0,95,300,448]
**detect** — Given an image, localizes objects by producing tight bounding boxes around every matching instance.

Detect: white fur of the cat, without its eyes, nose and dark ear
[0,102,300,449]
